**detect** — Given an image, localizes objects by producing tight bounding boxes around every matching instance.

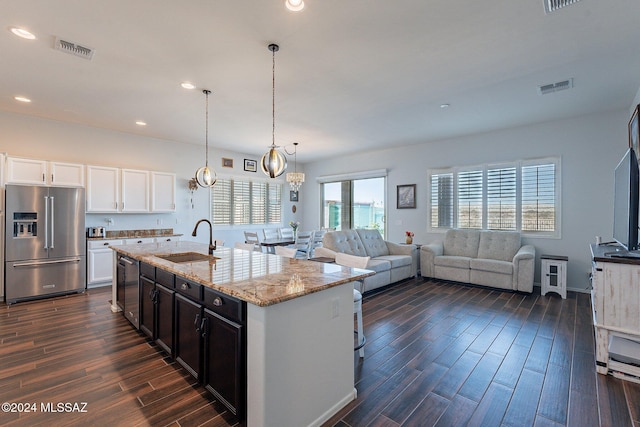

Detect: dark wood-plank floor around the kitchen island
[0,279,640,427]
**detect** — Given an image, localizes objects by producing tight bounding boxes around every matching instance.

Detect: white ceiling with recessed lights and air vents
[0,0,640,162]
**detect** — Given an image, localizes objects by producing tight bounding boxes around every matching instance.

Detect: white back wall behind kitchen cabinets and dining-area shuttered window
[0,112,300,246]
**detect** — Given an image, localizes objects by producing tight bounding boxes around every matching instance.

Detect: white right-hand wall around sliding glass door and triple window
[300,109,629,290]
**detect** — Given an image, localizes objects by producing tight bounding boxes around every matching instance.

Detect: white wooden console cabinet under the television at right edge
[591,245,640,382]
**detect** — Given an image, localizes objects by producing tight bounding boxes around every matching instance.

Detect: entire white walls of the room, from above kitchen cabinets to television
[0,109,630,289]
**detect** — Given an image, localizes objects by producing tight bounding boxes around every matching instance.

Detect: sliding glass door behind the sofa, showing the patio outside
[322,177,386,236]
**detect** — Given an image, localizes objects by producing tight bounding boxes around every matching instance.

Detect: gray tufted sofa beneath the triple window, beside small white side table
[420,229,536,293]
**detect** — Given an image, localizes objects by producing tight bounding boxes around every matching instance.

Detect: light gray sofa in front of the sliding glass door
[314,229,418,292]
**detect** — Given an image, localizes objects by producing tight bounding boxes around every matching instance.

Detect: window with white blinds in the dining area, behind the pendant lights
[211,179,282,225]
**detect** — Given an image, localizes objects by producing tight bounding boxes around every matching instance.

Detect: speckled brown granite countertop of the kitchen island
[110,242,375,307]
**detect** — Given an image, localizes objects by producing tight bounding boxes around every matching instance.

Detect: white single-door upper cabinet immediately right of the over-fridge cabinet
[87,166,120,212]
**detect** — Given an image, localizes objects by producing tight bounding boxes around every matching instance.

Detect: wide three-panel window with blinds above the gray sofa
[428,158,560,237]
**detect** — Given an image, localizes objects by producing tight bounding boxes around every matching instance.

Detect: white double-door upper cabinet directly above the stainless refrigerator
[6,157,84,187]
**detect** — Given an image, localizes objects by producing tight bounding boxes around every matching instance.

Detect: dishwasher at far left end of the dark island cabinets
[116,255,140,329]
